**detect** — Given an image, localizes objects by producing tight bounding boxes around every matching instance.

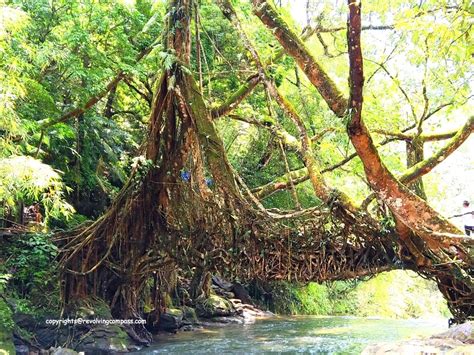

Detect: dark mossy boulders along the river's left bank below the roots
[0,276,272,355]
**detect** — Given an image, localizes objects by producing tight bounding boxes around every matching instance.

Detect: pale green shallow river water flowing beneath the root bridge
[134,316,447,354]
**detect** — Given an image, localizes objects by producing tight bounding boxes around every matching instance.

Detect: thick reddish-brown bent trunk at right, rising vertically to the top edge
[347,0,461,249]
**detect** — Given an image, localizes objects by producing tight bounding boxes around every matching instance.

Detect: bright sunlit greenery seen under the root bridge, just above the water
[272,271,450,318]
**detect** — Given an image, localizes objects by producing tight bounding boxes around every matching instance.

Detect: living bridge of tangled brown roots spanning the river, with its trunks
[58,0,474,342]
